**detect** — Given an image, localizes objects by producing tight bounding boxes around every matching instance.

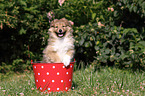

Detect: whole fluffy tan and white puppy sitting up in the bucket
[43,18,75,67]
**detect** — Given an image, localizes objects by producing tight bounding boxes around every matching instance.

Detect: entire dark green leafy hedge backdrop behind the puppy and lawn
[0,0,145,73]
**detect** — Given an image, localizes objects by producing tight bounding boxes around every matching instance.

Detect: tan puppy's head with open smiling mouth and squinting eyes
[49,18,73,38]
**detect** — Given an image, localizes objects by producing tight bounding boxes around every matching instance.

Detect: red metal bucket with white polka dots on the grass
[31,61,75,92]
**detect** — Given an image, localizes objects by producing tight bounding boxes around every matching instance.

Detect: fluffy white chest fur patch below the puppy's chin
[53,38,73,61]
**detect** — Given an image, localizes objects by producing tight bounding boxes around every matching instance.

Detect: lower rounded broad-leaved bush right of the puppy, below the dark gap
[75,23,145,68]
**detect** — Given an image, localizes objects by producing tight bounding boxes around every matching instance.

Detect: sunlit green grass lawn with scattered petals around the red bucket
[0,65,145,96]
